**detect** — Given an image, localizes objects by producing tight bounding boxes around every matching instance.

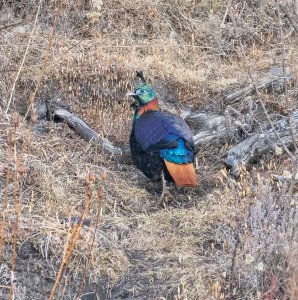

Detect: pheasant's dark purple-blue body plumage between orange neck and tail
[130,110,194,181]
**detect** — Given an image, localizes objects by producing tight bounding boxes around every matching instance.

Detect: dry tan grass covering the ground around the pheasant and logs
[0,0,298,300]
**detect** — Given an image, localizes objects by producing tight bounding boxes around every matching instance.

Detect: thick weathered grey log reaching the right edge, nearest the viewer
[224,110,298,176]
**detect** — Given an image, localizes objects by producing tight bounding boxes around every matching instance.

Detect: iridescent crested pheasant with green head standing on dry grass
[127,72,198,203]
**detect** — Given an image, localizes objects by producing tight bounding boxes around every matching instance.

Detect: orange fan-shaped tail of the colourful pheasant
[164,160,198,187]
